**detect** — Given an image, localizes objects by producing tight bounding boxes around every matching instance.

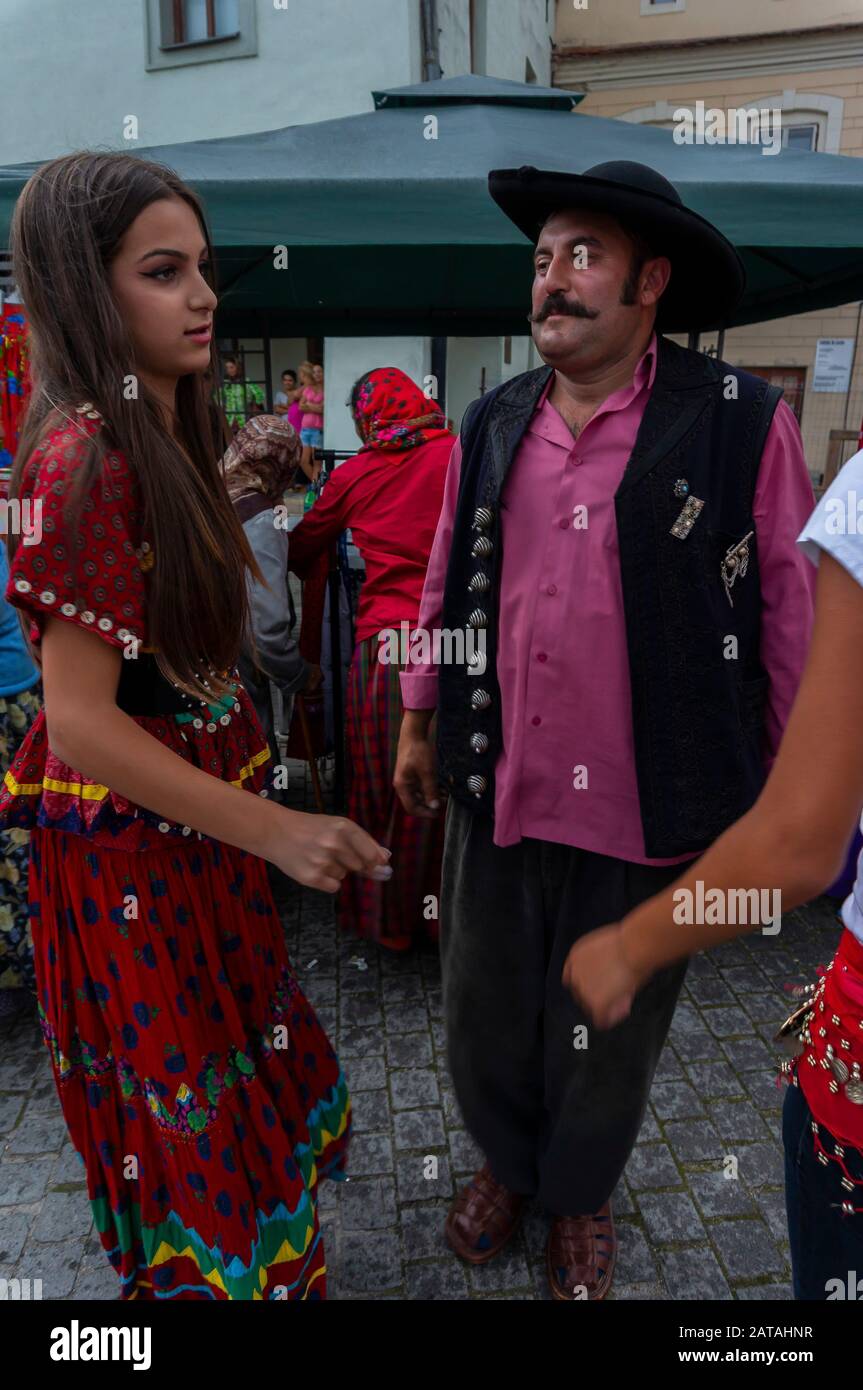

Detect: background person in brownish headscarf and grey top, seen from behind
[222,416,321,763]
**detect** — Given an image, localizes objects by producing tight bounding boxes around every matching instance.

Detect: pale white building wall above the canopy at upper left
[0,0,421,164]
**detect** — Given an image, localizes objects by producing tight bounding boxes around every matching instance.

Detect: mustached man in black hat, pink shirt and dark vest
[396,161,813,1300]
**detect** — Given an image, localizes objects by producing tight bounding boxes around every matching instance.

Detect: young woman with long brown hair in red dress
[0,153,389,1300]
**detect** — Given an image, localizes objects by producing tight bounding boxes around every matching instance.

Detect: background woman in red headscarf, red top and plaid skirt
[289,367,454,951]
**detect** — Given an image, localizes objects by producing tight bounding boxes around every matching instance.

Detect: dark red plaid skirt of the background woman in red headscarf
[338,637,443,951]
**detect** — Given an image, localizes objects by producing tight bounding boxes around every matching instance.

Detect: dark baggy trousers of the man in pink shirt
[441,801,687,1216]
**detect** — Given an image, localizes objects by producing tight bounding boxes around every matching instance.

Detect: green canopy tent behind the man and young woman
[0,76,863,336]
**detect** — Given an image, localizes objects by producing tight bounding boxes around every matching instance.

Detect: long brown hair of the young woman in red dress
[10,152,261,699]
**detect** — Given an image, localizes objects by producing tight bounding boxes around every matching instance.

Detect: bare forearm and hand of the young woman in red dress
[42,619,392,892]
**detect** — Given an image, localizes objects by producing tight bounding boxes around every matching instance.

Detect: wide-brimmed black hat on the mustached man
[488,160,746,334]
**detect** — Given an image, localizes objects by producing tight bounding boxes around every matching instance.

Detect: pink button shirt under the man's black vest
[402,336,814,865]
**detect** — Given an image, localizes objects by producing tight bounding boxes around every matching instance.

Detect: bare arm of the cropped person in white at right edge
[563,553,863,1027]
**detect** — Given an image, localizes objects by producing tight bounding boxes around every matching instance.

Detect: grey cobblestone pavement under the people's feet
[0,767,839,1300]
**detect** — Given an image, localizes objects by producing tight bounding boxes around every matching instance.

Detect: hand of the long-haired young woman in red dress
[265,802,392,892]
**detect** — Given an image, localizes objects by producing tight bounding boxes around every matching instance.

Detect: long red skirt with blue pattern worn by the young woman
[31,830,350,1300]
